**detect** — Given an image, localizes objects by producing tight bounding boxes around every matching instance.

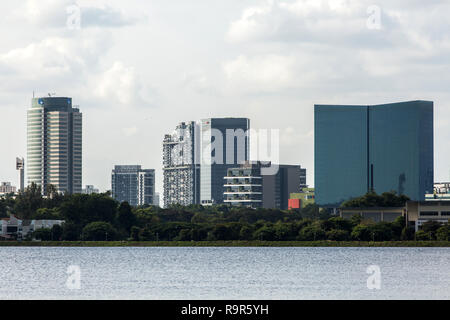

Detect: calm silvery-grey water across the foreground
[0,247,450,299]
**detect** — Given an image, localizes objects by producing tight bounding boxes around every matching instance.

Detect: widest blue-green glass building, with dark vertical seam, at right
[314,101,434,207]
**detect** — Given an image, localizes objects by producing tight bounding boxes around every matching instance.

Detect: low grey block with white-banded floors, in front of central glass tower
[224,161,301,210]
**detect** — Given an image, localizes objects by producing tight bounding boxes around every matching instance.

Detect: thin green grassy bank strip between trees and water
[0,240,450,248]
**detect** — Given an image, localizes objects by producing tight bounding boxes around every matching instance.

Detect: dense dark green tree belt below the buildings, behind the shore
[0,185,450,241]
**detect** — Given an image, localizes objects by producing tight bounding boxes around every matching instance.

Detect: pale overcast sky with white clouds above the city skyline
[0,0,450,199]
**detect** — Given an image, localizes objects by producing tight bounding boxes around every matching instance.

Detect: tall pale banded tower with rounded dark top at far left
[27,97,82,194]
